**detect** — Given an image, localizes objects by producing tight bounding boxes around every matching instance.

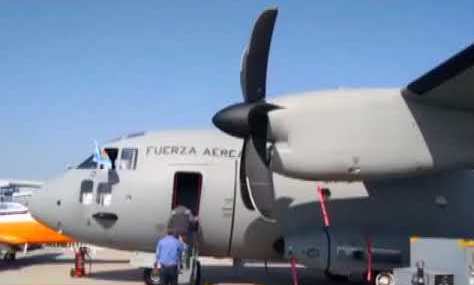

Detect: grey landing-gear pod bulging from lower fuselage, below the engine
[285,229,410,276]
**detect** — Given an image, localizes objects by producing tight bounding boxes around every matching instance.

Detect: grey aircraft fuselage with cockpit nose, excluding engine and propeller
[31,127,474,272]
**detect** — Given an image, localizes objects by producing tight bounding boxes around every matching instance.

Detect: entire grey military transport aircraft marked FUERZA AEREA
[31,6,474,284]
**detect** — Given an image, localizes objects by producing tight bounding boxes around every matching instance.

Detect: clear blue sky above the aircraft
[0,0,474,179]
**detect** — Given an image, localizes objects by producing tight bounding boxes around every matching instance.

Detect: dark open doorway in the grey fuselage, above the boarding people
[171,172,202,216]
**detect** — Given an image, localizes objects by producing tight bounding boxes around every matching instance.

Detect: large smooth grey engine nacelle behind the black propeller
[269,90,474,180]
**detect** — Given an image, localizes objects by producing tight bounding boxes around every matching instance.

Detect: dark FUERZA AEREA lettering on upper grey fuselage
[146,145,240,158]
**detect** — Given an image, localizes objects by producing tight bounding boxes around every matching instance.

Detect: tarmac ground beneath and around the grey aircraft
[0,245,360,285]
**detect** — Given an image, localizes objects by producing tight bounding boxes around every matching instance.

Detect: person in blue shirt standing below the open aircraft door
[156,228,184,285]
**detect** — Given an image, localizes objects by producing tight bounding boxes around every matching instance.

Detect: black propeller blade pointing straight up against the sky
[240,8,278,103]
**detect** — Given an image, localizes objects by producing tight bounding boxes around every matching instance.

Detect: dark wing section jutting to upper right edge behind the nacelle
[403,44,474,111]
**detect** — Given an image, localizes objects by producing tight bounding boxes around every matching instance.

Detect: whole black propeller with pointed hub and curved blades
[212,8,280,219]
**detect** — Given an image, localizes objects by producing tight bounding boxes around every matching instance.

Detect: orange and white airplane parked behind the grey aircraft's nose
[0,180,74,261]
